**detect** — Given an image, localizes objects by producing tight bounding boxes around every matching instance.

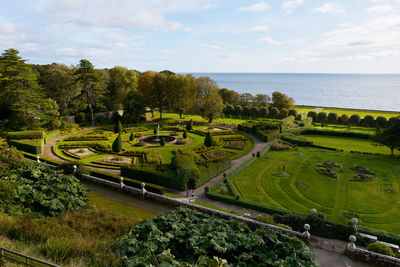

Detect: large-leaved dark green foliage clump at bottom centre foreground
[116,208,317,266]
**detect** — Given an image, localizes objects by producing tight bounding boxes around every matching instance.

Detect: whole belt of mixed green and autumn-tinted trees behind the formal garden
[0,49,294,129]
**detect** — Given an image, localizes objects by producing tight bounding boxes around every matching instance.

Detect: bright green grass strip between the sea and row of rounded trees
[296,106,400,119]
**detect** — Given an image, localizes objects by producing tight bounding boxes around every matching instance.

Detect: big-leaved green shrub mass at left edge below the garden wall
[0,162,87,217]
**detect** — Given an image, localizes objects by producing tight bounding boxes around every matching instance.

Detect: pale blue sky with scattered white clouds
[0,0,400,73]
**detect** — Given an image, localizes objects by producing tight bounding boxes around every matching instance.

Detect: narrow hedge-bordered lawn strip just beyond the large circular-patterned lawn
[301,135,396,155]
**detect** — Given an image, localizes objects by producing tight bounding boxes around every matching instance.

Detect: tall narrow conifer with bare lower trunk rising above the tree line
[75,59,103,126]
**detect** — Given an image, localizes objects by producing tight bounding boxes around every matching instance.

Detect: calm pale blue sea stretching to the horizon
[193,73,400,111]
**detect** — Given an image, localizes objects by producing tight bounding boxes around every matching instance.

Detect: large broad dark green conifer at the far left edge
[0,49,59,129]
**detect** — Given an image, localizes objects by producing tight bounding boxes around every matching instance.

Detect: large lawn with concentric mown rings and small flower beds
[231,148,400,234]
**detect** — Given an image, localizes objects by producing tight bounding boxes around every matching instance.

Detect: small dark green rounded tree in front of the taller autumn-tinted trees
[123,91,146,123]
